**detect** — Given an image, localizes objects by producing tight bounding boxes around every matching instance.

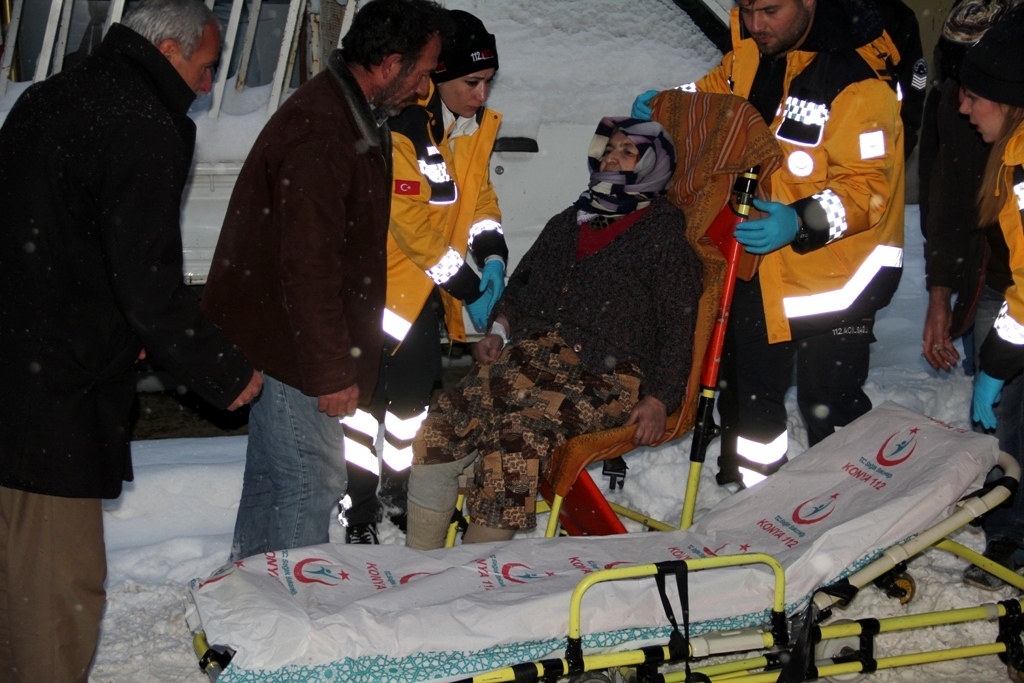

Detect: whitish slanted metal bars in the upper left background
[0,0,348,113]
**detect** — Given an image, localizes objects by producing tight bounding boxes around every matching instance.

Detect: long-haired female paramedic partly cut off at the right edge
[961,5,1024,590]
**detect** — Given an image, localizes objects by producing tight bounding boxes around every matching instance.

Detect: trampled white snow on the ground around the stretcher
[90,207,1016,683]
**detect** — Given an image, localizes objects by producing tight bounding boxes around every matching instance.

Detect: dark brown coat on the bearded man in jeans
[203,52,391,401]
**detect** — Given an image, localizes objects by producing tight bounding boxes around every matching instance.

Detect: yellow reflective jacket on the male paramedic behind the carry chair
[696,8,904,343]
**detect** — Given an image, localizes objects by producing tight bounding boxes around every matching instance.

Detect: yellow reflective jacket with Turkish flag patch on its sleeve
[384,85,508,341]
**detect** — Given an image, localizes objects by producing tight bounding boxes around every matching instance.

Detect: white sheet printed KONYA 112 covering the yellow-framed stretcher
[189,403,998,683]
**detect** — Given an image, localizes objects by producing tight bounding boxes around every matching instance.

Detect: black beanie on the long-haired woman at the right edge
[961,5,1024,106]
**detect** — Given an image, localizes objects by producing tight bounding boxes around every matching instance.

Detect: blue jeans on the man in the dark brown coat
[231,374,348,561]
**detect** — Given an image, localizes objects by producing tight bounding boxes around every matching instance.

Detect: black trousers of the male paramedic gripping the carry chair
[718,278,874,473]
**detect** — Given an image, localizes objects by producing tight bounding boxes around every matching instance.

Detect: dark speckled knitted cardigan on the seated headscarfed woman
[494,200,702,412]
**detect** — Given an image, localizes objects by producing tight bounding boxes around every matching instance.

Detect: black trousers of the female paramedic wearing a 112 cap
[346,296,442,524]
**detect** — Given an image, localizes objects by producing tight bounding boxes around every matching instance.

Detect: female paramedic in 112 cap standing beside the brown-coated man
[343,10,508,544]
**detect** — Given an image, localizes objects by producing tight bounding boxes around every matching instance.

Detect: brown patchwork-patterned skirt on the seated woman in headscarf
[413,332,641,530]
